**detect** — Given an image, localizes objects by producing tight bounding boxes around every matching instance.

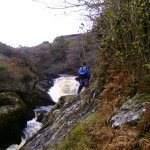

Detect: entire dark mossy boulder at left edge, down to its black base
[0,92,27,149]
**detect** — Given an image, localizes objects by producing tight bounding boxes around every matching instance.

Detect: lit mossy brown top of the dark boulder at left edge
[0,92,26,127]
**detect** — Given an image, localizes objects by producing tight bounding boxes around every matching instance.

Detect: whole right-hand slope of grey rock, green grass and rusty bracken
[21,78,150,150]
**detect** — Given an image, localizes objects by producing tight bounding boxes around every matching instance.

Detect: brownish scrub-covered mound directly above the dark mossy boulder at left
[0,60,34,90]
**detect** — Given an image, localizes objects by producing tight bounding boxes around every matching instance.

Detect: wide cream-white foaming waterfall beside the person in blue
[48,76,79,102]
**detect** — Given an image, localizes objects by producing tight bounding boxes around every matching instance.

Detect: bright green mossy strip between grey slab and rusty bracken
[55,112,99,150]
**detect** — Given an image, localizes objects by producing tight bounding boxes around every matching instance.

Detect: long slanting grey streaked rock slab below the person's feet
[21,96,96,150]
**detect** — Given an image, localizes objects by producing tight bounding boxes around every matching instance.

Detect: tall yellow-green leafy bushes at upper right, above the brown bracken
[90,0,150,91]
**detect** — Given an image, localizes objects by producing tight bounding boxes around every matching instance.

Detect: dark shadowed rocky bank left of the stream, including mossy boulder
[0,76,55,149]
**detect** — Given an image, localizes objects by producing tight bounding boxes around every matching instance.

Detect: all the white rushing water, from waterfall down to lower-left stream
[7,75,79,150]
